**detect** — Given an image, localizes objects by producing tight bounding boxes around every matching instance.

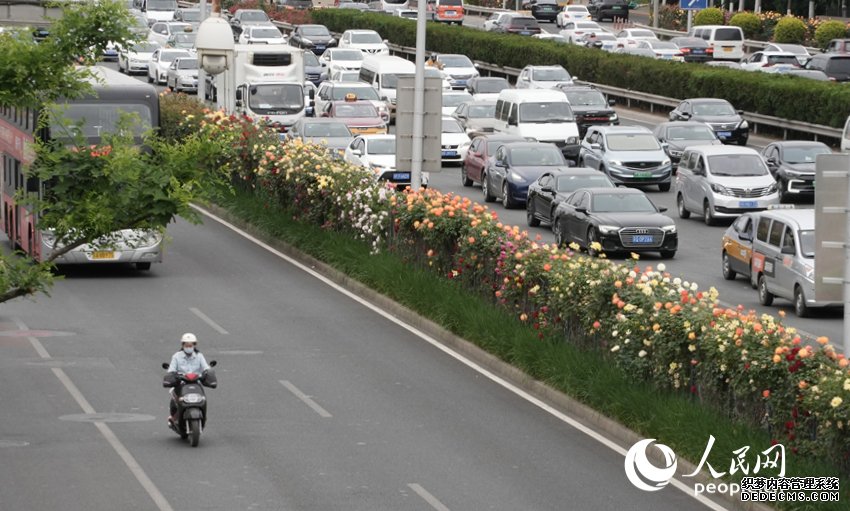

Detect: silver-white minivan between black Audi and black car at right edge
[676,145,779,225]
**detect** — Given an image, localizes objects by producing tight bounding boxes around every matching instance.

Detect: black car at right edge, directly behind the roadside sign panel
[761,140,832,202]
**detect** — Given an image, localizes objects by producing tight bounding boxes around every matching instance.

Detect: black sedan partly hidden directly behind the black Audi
[525,167,616,227]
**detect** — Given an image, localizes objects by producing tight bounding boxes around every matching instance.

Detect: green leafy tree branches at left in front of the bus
[0,0,229,302]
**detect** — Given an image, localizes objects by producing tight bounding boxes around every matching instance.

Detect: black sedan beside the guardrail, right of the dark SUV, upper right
[670,98,750,145]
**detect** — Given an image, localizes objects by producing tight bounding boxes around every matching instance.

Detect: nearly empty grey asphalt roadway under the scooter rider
[0,213,724,511]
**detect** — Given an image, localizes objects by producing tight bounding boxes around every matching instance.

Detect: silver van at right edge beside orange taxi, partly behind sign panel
[750,209,842,317]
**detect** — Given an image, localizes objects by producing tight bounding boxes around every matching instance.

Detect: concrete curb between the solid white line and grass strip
[196,204,774,511]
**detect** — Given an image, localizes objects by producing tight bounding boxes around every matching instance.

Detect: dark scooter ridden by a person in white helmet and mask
[162,360,218,447]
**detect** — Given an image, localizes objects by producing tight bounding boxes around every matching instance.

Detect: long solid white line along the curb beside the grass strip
[192,204,726,511]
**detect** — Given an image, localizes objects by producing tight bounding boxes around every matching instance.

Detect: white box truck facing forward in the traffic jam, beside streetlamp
[213,44,314,131]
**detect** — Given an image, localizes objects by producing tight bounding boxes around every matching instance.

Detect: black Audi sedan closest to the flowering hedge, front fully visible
[553,188,679,258]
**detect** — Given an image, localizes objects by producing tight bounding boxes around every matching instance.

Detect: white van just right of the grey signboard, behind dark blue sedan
[496,89,581,161]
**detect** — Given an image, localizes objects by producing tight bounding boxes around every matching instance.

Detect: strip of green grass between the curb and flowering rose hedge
[217,189,850,511]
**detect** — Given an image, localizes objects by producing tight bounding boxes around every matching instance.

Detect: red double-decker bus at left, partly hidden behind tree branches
[0,67,162,270]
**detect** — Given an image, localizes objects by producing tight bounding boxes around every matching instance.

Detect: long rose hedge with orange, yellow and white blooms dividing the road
[172,97,850,463]
